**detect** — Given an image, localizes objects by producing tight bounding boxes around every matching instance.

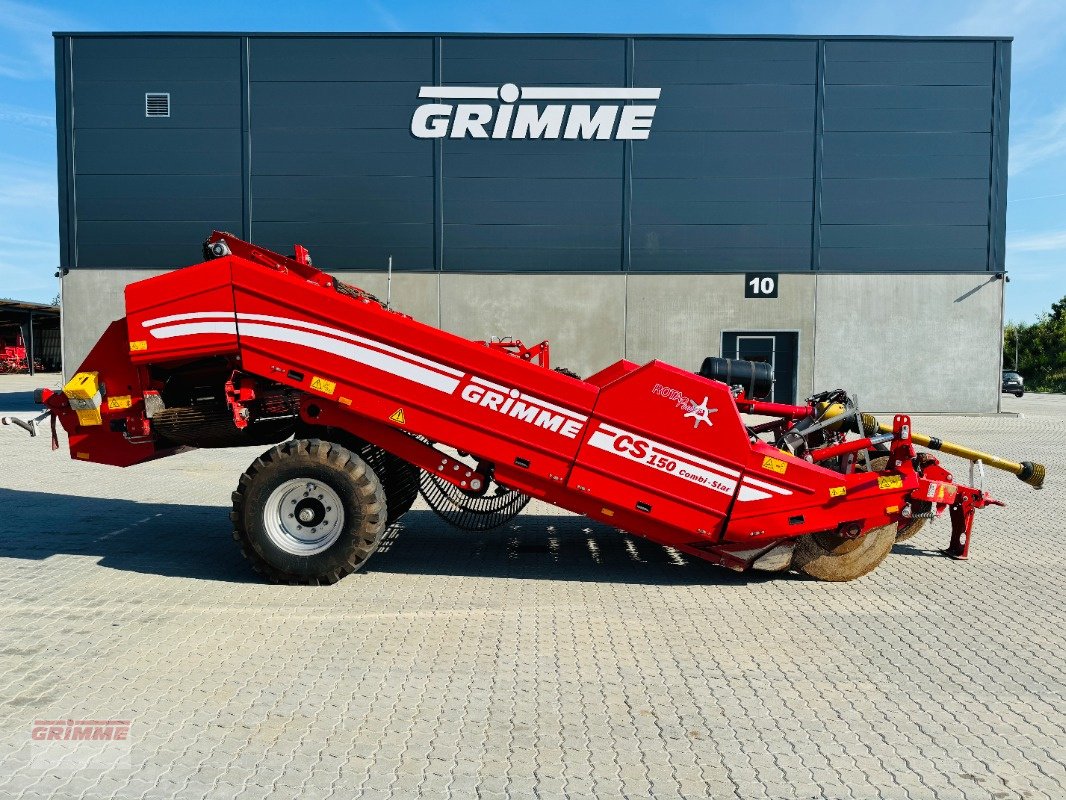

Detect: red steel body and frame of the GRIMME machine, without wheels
[46,233,994,569]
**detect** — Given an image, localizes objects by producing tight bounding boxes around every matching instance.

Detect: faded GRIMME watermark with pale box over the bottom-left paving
[30,717,132,772]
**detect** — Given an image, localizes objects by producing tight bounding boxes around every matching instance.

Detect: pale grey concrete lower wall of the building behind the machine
[63,269,1003,413]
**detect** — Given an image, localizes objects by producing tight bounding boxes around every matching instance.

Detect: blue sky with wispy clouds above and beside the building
[0,0,1066,322]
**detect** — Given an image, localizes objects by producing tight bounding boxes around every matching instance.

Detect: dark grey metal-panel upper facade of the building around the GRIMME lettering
[55,33,1011,273]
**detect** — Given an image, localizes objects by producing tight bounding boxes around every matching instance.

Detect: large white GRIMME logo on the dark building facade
[410,83,662,140]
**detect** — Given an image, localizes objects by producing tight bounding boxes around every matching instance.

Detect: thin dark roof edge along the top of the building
[52,31,1014,42]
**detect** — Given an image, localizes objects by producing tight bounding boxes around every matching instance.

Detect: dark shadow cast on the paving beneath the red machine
[0,489,771,586]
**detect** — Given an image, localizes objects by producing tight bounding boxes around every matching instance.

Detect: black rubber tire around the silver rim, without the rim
[229,439,386,586]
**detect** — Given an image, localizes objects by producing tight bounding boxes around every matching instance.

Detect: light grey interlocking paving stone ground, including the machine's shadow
[0,377,1066,800]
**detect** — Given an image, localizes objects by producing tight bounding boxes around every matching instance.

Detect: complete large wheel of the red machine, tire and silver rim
[230,439,386,585]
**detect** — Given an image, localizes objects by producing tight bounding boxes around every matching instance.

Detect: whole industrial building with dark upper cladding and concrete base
[55,33,1011,412]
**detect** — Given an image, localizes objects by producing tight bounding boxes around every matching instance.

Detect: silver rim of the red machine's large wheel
[263,478,344,556]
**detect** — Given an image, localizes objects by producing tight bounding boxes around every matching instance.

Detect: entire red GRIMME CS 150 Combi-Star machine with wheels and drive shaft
[3,231,1044,583]
